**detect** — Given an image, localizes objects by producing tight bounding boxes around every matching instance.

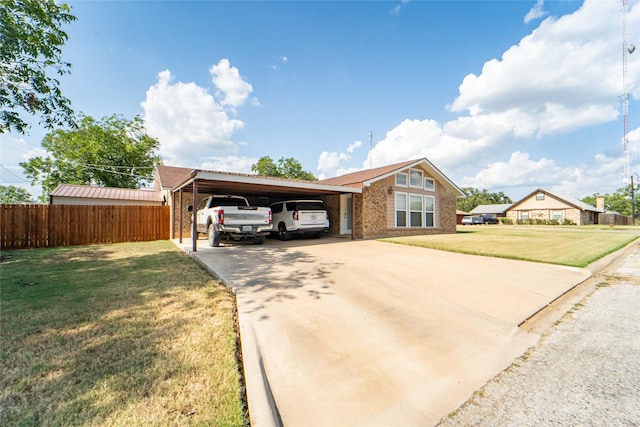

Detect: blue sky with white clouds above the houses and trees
[0,0,640,201]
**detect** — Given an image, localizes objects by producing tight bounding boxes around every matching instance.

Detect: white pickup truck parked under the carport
[191,195,273,247]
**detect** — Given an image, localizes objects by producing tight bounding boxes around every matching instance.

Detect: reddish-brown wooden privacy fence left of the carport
[0,205,171,249]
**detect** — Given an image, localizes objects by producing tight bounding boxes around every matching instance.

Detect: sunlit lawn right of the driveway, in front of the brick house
[381,225,640,267]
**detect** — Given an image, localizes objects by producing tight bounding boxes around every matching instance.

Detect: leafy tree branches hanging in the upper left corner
[0,0,76,134]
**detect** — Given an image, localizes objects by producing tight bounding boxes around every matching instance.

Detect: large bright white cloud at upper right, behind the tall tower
[450,0,640,136]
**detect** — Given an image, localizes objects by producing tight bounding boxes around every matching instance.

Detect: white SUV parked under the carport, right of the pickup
[271,200,329,240]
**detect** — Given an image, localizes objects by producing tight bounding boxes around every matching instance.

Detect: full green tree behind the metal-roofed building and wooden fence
[20,115,162,201]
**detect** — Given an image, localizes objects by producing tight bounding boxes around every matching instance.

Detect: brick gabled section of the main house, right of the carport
[320,158,464,238]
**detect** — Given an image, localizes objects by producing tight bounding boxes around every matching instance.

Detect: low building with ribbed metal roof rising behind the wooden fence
[49,184,165,206]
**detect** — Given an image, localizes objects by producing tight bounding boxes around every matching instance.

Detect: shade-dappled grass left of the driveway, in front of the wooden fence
[0,241,248,426]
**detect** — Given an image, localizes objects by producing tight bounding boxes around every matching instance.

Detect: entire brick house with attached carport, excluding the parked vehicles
[156,159,464,244]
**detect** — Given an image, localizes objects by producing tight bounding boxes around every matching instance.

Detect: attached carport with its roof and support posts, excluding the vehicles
[171,169,362,252]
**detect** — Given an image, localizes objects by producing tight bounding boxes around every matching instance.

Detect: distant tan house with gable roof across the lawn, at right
[507,188,603,225]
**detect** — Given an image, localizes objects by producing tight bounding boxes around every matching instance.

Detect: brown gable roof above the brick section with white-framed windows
[319,158,464,197]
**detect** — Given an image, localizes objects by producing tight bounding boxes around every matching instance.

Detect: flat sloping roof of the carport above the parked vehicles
[168,169,362,198]
